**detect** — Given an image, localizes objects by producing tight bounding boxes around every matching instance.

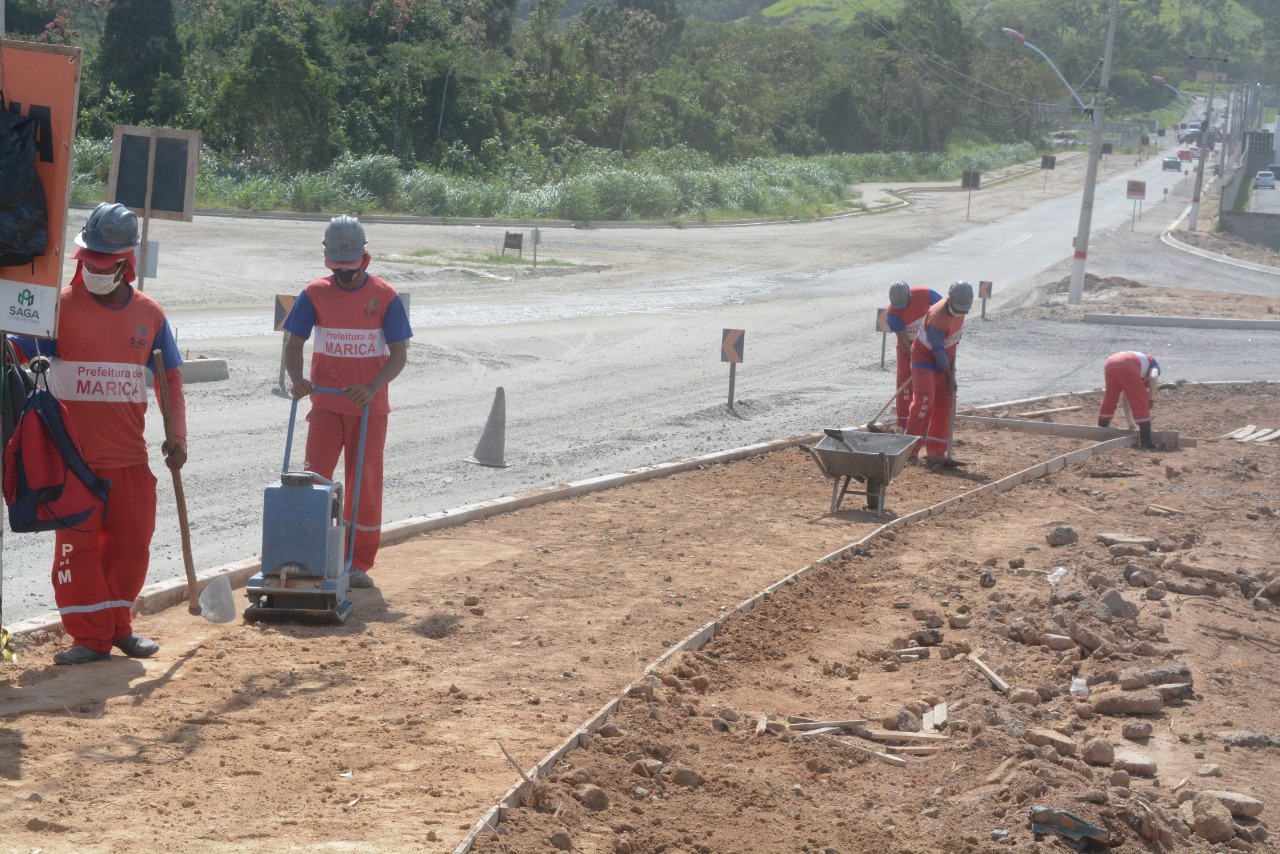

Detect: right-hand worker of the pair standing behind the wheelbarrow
[906,282,973,467]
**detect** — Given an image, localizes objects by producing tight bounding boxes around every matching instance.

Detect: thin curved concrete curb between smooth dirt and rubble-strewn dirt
[453,435,1137,854]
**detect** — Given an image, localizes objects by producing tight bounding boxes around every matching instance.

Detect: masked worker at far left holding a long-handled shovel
[15,204,187,665]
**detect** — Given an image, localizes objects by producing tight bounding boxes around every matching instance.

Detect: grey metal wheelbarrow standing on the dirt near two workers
[800,428,919,517]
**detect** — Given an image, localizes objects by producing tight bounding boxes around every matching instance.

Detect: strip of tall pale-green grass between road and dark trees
[72,141,1036,222]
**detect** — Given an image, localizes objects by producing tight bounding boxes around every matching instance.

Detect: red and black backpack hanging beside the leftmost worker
[4,376,111,534]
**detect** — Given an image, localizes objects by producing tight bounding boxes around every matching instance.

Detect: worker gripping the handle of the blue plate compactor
[284,216,413,588]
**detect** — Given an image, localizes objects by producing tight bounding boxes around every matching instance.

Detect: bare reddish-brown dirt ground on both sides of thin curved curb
[0,376,1280,851]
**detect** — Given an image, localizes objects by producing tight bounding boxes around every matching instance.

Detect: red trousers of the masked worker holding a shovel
[52,465,156,653]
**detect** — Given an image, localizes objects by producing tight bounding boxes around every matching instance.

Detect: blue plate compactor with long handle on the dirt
[244,388,369,624]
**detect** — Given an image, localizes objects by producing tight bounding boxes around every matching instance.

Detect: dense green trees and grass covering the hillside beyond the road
[8,0,1280,219]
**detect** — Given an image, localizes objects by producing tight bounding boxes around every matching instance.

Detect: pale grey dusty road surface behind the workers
[4,145,1280,625]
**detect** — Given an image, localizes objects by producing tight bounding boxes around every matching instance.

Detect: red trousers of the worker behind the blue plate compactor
[306,408,387,570]
